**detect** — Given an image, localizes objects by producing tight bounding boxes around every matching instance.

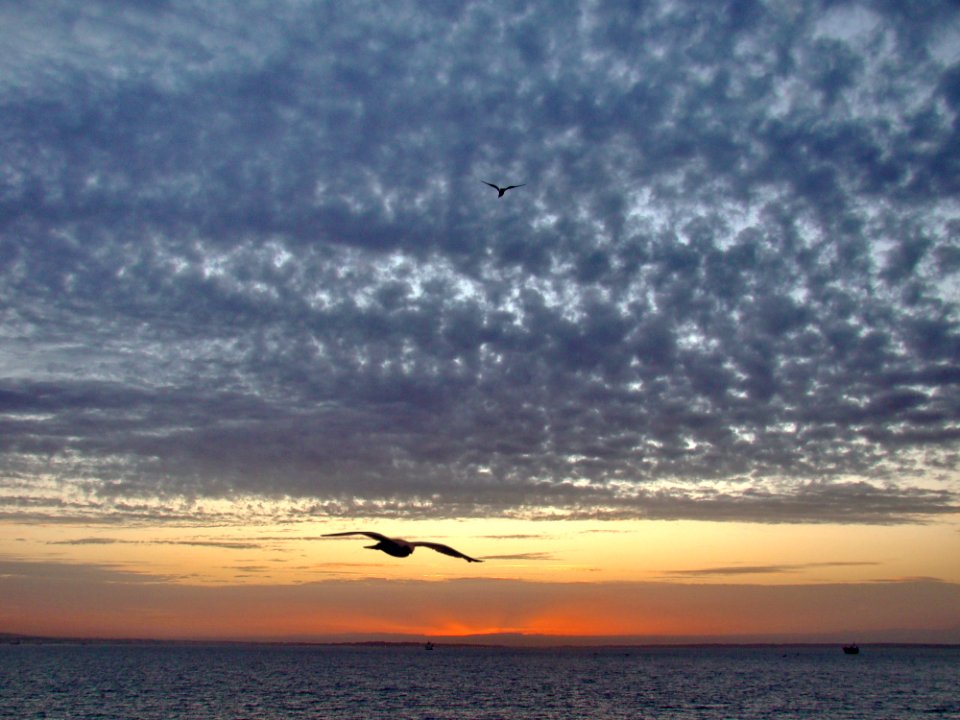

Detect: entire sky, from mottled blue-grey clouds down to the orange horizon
[0,0,960,642]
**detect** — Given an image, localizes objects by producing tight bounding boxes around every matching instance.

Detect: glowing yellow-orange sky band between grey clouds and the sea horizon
[0,520,960,642]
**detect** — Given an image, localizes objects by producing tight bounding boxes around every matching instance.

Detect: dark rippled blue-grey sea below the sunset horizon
[0,644,960,720]
